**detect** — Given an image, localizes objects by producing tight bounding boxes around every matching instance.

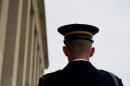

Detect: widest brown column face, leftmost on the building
[1,0,19,86]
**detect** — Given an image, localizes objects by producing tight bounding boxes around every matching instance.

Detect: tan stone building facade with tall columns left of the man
[0,0,48,86]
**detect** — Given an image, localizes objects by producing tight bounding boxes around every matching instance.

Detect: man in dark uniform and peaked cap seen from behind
[39,24,123,86]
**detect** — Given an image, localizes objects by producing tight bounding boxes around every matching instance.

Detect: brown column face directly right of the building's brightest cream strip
[16,0,29,86]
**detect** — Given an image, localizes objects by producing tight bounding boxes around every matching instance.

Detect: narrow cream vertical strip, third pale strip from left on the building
[22,0,32,86]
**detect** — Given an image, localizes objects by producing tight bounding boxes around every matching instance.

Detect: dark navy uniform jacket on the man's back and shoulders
[39,61,123,86]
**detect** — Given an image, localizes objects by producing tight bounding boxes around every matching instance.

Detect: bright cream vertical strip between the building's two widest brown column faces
[12,0,23,86]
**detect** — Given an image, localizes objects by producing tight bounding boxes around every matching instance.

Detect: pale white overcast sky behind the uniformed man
[45,0,130,86]
